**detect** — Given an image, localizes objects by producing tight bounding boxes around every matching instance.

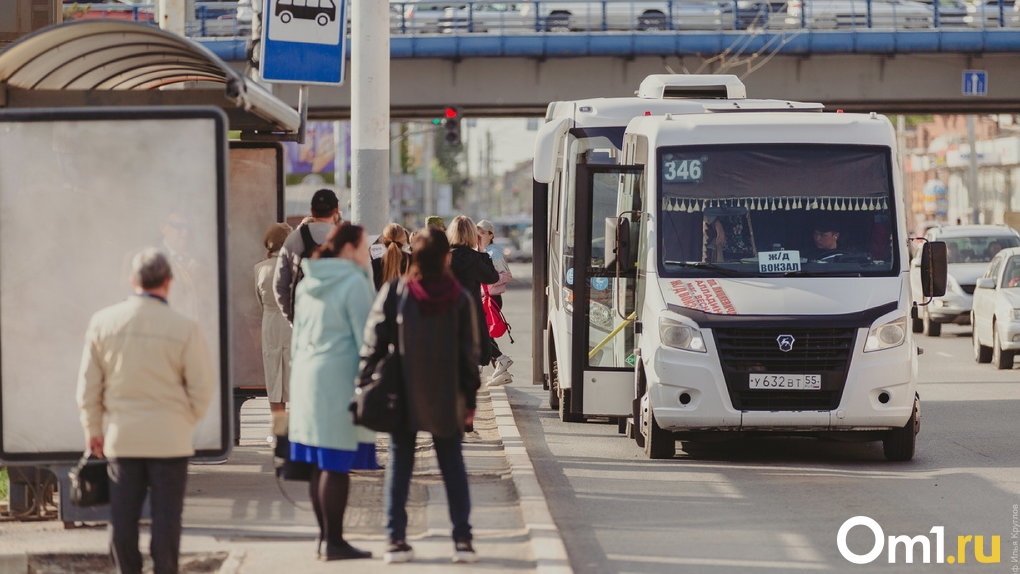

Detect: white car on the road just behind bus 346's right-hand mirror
[910,225,1020,336]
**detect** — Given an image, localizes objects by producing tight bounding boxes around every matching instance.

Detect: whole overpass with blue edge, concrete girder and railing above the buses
[23,0,1020,119]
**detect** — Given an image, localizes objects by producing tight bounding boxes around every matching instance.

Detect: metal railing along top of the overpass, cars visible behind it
[64,0,1020,38]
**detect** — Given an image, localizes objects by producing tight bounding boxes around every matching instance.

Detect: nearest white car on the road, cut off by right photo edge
[970,247,1020,369]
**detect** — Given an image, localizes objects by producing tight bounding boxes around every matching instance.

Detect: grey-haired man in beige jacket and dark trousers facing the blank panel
[78,249,215,574]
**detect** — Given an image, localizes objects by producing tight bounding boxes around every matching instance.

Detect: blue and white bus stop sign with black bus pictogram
[260,0,347,86]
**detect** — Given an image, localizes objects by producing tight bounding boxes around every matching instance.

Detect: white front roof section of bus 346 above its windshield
[626,112,896,148]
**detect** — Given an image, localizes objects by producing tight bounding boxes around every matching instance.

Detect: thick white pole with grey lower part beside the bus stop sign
[351,1,390,233]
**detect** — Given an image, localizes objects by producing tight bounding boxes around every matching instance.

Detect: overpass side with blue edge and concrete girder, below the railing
[206,30,1020,119]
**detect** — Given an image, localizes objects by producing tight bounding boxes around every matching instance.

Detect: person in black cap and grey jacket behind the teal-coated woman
[272,189,341,323]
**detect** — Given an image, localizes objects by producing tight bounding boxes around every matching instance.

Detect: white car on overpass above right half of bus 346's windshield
[785,0,933,29]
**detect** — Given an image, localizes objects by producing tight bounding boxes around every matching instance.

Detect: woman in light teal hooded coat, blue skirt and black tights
[290,223,377,561]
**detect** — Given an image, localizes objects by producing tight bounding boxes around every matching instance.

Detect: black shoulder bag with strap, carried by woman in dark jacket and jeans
[350,289,407,432]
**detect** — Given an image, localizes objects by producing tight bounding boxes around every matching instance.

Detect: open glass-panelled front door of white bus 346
[564,164,644,417]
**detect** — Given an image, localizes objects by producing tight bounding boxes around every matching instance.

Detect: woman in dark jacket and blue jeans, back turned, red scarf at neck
[361,229,480,563]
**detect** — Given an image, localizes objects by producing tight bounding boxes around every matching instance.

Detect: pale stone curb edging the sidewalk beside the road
[489,386,573,574]
